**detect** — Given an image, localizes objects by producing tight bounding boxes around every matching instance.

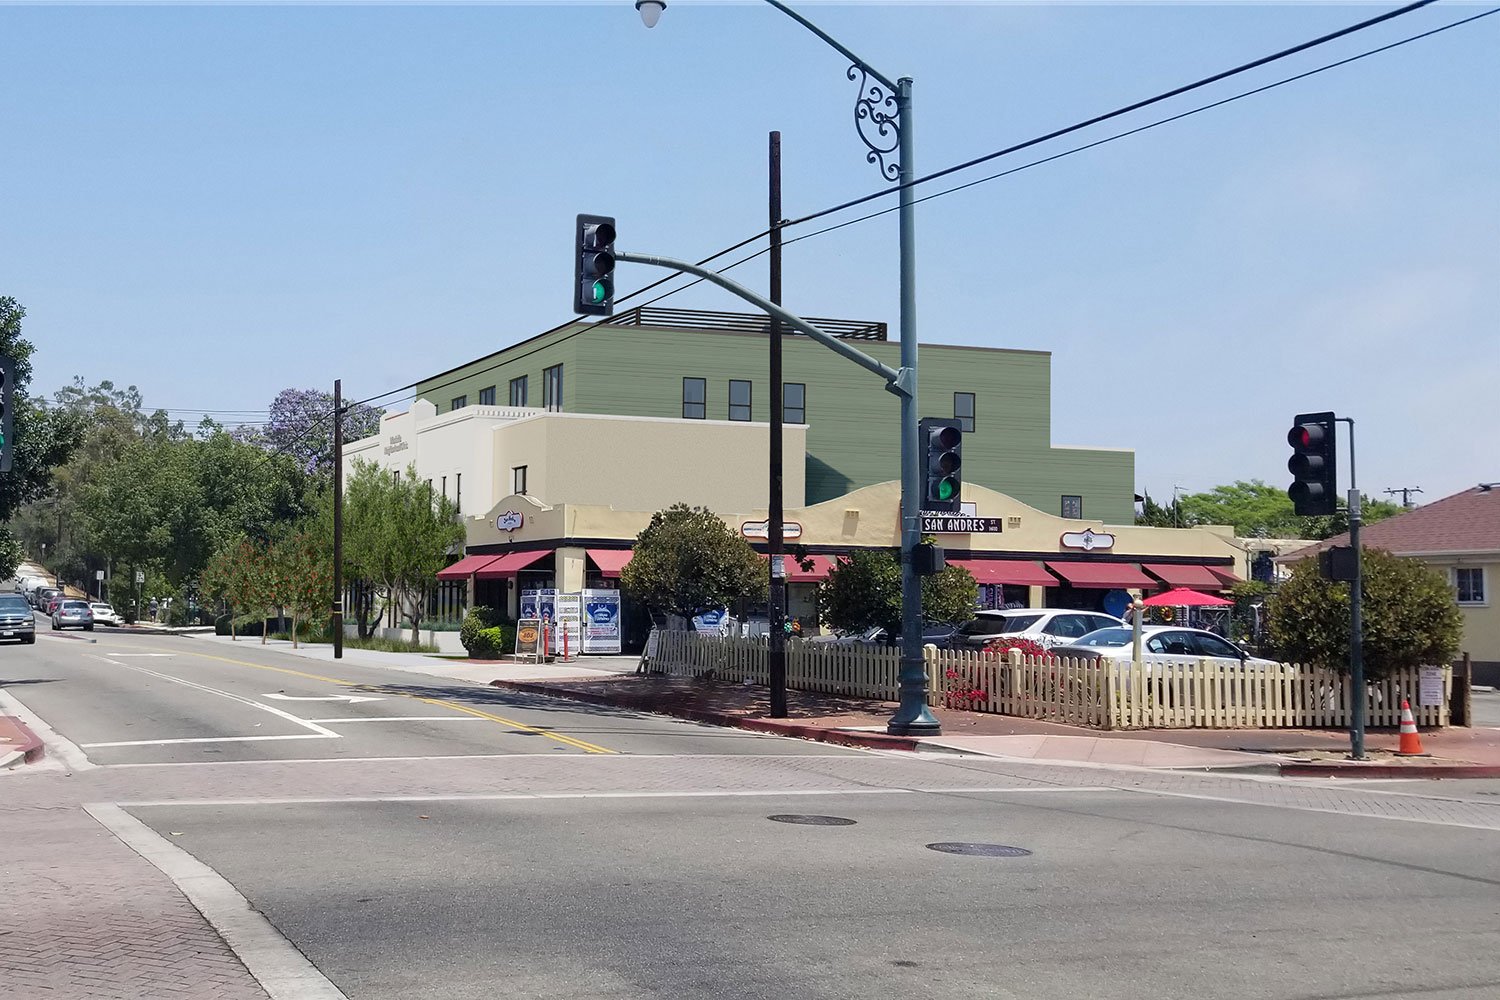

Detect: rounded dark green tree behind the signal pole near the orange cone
[1266,549,1463,681]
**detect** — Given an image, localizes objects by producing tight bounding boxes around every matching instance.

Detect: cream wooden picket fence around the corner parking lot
[648,631,1452,729]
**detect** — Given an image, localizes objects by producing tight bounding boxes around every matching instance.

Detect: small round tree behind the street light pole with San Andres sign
[818,549,980,636]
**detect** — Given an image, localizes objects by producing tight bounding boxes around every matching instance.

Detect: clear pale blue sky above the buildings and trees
[0,0,1500,509]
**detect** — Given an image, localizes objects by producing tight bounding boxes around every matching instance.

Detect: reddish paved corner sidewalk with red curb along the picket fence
[494,675,1500,778]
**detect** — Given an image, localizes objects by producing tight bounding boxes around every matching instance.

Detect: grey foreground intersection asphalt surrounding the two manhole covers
[132,790,1500,1000]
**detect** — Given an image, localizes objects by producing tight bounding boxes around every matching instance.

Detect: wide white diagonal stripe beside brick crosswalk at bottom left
[84,804,348,1000]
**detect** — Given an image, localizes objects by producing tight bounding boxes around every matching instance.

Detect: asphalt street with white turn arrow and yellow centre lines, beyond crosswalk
[0,624,849,765]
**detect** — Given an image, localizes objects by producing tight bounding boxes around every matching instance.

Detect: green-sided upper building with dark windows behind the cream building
[417,307,1136,523]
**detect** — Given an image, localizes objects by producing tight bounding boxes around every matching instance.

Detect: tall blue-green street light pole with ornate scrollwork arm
[639,0,942,736]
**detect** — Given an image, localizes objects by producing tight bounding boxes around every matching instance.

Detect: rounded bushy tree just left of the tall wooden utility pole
[620,504,770,619]
